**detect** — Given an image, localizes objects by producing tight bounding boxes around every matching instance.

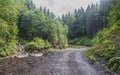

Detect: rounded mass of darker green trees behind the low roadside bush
[18,9,68,48]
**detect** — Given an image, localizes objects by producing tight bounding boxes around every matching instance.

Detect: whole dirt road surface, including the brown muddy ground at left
[0,47,106,75]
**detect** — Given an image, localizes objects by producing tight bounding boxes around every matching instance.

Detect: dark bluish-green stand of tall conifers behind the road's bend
[62,0,110,44]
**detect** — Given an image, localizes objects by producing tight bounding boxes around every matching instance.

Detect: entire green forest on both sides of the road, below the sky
[0,0,120,74]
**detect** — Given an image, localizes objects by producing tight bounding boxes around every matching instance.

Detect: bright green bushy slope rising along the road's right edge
[86,0,120,75]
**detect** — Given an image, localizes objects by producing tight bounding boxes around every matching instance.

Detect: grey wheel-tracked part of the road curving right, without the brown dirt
[52,47,105,75]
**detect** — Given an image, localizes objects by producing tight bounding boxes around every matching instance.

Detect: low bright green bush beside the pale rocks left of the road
[25,38,51,51]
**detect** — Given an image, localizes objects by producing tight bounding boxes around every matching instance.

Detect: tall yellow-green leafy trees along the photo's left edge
[0,0,19,56]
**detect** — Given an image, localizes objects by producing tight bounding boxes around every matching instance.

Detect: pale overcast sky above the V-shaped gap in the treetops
[33,0,99,16]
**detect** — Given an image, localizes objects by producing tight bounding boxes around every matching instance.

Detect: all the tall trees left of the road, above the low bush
[0,0,67,56]
